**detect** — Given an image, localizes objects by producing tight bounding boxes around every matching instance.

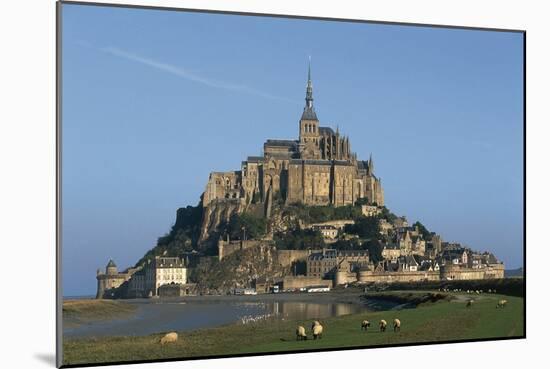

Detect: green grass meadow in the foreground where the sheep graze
[64,292,524,365]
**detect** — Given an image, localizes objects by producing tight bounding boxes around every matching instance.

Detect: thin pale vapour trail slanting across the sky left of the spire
[101,47,297,104]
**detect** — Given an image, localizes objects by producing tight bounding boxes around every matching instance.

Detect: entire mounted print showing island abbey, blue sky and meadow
[57,3,525,366]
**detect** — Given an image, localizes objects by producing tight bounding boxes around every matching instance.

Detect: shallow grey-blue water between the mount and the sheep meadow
[63,298,378,337]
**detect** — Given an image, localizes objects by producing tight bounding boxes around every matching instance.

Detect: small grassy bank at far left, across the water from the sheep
[63,299,137,326]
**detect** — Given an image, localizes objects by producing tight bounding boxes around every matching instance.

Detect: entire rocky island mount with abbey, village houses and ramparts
[96,68,504,298]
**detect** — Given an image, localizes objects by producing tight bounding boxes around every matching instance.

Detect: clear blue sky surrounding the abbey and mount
[62,4,523,295]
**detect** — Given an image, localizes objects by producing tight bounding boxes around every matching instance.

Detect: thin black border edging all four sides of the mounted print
[55,0,527,368]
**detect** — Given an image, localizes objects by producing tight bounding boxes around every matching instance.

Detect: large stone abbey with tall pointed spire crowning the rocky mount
[202,64,384,207]
